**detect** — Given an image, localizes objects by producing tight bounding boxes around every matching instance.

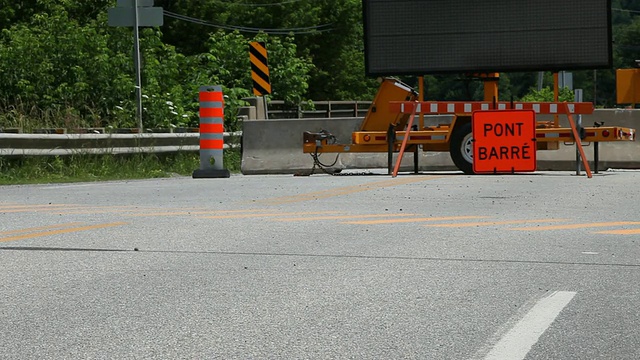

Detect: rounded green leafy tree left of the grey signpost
[0,6,131,126]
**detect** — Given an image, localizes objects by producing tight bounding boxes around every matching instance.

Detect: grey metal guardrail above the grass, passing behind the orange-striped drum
[0,131,242,156]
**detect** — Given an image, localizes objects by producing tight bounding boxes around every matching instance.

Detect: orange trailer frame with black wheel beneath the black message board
[303,74,636,174]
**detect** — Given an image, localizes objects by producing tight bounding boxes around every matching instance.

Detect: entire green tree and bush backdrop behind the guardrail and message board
[0,0,640,130]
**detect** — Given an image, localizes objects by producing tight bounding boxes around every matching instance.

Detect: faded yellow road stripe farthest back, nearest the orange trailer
[253,176,442,205]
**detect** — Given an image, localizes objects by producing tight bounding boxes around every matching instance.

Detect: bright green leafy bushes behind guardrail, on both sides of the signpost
[0,2,313,131]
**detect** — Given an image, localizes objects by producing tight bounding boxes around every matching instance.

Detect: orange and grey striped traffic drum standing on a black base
[193,86,231,179]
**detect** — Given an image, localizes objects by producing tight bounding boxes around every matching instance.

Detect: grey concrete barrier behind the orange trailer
[242,109,640,174]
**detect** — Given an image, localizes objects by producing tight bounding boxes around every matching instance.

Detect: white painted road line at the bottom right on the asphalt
[484,291,576,360]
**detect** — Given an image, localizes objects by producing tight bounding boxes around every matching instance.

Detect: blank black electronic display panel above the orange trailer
[363,0,612,76]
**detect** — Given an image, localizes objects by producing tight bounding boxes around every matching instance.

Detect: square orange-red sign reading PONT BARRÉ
[471,110,536,173]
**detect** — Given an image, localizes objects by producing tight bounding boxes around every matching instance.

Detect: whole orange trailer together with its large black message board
[303,0,635,174]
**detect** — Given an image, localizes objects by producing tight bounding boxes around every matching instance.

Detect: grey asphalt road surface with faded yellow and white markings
[0,171,640,360]
